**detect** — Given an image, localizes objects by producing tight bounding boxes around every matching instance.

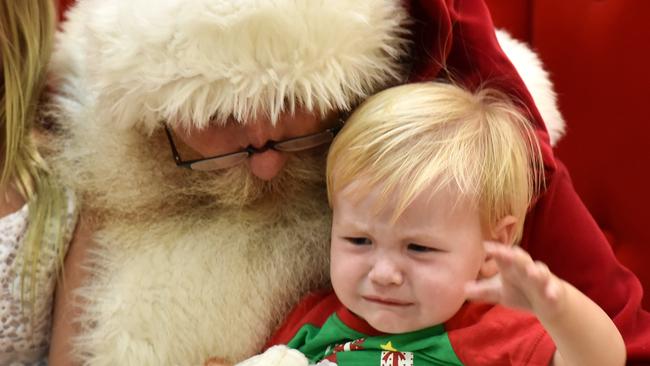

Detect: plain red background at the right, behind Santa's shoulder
[486,0,650,309]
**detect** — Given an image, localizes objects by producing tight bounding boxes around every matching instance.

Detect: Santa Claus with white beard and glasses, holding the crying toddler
[50,0,650,365]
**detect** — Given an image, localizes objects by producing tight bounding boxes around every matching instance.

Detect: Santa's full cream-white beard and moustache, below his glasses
[52,106,331,365]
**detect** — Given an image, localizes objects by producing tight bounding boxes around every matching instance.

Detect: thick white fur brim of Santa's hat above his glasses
[55,0,408,131]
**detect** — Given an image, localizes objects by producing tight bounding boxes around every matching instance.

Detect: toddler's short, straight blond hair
[327,82,543,242]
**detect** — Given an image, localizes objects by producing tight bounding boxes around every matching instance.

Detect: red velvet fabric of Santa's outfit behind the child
[407,0,650,364]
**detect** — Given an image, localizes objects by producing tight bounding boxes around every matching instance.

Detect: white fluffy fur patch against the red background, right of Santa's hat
[496,30,565,146]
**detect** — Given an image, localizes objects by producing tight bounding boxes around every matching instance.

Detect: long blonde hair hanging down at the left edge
[0,0,67,302]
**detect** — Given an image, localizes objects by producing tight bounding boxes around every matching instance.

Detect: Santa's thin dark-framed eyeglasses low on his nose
[163,119,343,171]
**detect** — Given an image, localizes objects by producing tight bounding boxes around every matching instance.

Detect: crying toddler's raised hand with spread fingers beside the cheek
[465,242,565,317]
